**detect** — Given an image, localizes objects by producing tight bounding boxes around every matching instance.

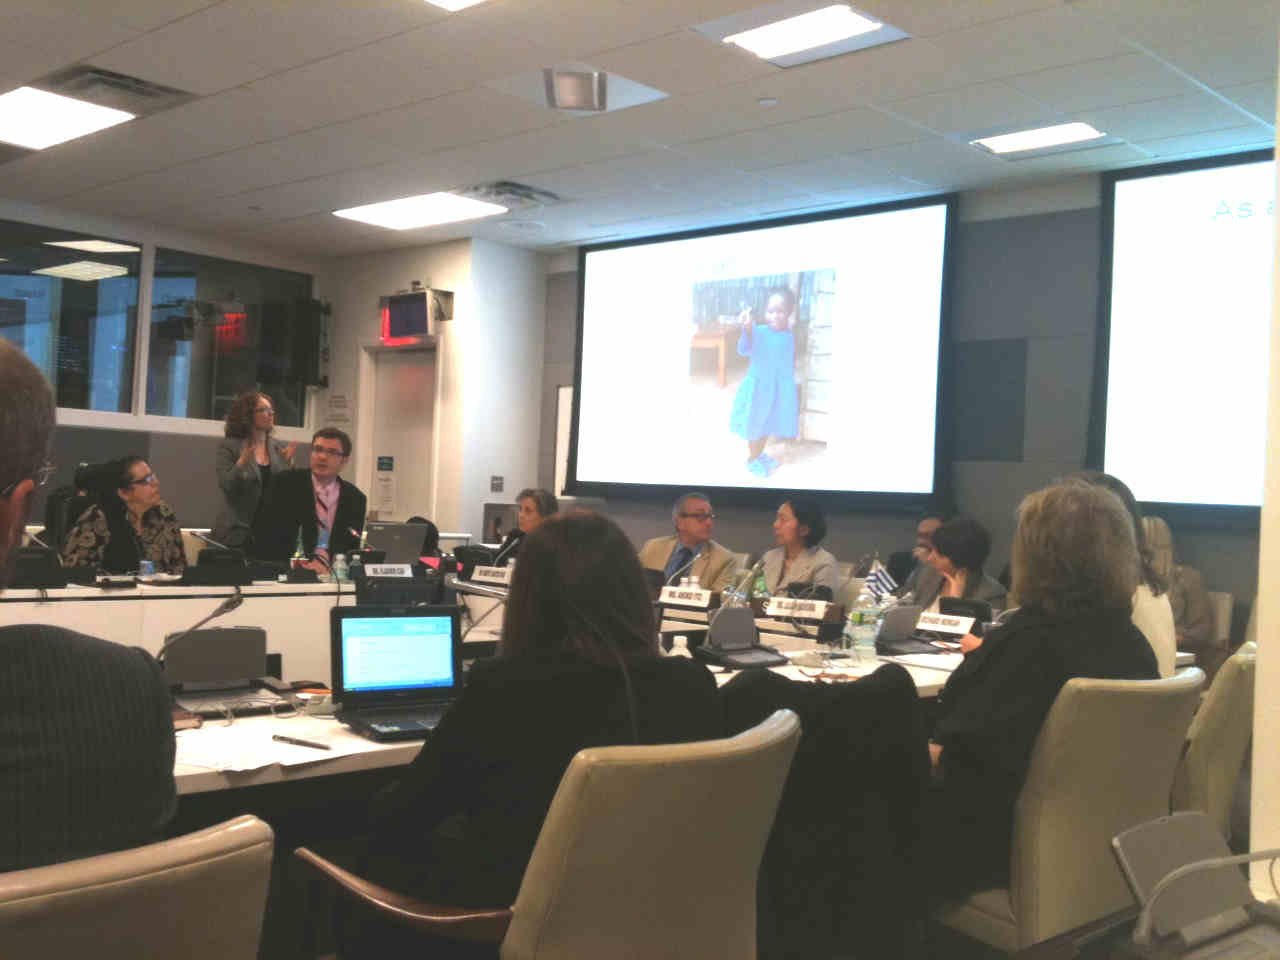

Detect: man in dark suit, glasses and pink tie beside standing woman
[259,426,367,573]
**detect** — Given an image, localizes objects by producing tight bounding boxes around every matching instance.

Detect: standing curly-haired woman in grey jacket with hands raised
[212,390,297,549]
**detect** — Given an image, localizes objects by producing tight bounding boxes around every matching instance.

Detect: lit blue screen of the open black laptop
[339,613,454,694]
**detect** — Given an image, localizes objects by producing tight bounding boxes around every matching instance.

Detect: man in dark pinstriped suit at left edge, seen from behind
[0,338,177,872]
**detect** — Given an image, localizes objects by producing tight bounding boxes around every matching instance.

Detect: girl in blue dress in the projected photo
[730,287,800,476]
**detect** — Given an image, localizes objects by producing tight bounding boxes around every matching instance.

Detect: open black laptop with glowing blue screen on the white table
[329,607,462,741]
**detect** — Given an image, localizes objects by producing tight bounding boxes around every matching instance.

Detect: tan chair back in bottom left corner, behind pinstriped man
[0,817,273,960]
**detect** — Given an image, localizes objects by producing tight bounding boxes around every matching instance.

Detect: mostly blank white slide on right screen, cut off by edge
[1103,154,1275,506]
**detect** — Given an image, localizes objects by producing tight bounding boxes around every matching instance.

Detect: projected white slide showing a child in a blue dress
[576,202,947,494]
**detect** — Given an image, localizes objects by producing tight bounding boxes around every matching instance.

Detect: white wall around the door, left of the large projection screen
[320,232,545,532]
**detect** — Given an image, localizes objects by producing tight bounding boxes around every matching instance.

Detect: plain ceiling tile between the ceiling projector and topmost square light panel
[591,31,778,93]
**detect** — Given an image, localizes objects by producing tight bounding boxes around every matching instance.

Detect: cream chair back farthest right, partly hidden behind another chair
[1172,644,1257,840]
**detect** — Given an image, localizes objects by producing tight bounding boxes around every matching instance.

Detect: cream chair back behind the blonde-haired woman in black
[1010,667,1204,947]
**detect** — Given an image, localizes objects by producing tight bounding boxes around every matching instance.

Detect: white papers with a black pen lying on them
[177,721,367,773]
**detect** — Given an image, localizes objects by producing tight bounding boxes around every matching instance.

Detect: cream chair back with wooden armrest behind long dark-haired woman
[502,710,800,960]
